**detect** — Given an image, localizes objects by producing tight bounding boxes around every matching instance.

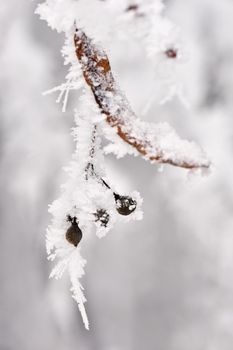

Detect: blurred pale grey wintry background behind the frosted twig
[0,0,233,350]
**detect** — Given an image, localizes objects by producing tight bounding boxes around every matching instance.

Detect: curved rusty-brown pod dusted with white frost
[74,29,210,169]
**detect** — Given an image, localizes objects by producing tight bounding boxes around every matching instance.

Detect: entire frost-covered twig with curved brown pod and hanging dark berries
[36,0,210,329]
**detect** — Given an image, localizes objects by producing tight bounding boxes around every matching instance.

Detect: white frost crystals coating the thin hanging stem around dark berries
[46,89,142,329]
